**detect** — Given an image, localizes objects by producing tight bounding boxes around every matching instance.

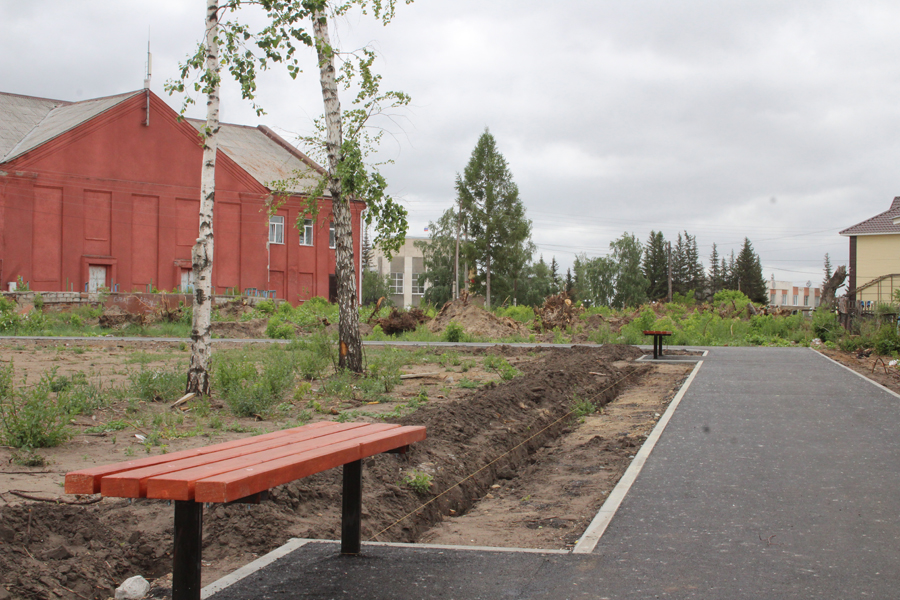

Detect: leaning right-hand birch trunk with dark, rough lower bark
[312,9,363,373]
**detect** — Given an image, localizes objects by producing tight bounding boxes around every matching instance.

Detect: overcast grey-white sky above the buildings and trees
[0,0,900,284]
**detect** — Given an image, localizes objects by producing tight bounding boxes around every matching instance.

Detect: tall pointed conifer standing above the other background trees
[456,128,534,308]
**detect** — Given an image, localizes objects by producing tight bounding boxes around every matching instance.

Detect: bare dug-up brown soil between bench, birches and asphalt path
[0,339,692,600]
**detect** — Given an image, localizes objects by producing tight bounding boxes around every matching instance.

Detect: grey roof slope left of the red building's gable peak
[0,90,142,163]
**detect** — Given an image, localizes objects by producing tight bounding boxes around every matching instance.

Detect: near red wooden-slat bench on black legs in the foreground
[65,422,425,600]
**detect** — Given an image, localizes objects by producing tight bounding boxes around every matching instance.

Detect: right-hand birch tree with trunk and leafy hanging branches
[170,0,412,372]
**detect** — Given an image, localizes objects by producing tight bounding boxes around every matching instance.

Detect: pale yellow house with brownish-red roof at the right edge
[841,197,900,308]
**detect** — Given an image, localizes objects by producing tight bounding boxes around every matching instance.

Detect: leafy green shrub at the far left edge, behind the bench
[0,363,69,449]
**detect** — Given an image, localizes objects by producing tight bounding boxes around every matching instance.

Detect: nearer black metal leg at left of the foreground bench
[172,500,203,600]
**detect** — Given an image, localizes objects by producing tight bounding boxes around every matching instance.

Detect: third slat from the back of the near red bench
[144,423,400,502]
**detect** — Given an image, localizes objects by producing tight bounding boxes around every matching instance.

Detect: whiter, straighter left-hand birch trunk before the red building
[185,0,219,395]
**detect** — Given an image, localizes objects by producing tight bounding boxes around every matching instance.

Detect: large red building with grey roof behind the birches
[0,90,365,304]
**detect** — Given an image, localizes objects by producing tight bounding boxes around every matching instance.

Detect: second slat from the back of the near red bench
[100,423,374,498]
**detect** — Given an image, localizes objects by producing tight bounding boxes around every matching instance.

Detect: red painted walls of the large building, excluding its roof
[0,94,364,304]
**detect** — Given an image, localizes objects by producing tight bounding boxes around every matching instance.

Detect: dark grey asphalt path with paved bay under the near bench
[207,348,900,600]
